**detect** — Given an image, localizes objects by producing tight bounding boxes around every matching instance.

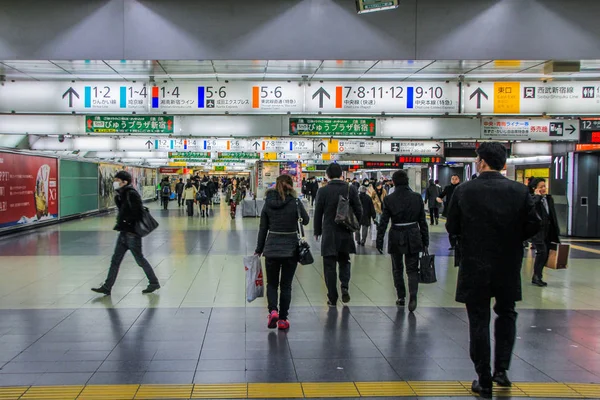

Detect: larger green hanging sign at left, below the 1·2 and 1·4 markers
[85,115,173,134]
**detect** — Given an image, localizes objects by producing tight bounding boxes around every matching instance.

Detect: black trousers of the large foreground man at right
[467,298,518,387]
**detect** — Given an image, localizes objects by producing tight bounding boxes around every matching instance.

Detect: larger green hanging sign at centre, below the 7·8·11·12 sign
[290,118,377,136]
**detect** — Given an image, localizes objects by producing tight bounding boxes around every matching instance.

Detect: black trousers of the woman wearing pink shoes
[265,257,298,320]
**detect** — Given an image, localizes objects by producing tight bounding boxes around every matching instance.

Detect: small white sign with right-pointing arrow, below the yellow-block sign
[481,118,579,141]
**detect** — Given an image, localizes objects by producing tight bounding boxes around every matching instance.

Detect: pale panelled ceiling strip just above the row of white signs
[0,60,600,81]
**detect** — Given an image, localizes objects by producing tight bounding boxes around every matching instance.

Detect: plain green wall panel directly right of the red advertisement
[59,160,98,217]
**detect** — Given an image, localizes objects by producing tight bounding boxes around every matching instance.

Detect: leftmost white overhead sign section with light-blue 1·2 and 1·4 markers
[0,81,150,113]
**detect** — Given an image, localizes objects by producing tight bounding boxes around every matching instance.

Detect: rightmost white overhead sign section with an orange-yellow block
[464,81,600,115]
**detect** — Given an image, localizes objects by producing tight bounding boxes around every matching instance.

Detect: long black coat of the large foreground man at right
[446,172,540,304]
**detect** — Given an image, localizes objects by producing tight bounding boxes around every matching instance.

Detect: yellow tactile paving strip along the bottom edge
[0,381,600,400]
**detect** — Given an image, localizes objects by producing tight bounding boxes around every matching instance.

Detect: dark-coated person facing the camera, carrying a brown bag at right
[530,178,560,287]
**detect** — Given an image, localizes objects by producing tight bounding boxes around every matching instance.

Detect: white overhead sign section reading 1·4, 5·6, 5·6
[150,82,304,114]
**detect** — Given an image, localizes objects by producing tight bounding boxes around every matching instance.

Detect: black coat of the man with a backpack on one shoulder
[314,179,362,257]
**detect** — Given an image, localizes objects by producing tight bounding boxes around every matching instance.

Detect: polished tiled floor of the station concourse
[0,203,600,399]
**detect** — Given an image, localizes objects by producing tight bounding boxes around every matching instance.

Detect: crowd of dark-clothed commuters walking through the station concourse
[92,142,560,398]
